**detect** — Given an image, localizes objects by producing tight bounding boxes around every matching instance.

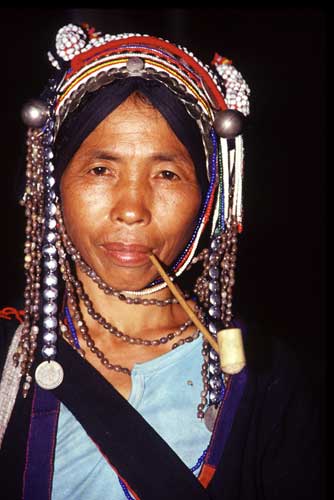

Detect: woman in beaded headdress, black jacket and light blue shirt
[0,24,319,500]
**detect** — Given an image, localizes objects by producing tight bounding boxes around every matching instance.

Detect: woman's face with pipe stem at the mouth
[61,96,201,290]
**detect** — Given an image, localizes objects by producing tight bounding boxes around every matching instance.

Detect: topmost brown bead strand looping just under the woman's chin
[57,206,185,307]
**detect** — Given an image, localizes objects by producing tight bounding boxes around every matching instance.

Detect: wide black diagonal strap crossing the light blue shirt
[53,339,209,500]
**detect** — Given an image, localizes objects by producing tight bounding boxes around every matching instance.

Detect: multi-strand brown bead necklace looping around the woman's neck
[56,207,224,422]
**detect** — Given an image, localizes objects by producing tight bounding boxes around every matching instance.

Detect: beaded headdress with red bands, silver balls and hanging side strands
[15,24,249,416]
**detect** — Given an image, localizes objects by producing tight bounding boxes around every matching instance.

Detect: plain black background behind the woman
[0,7,326,376]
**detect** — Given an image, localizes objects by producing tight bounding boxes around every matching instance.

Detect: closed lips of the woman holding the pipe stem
[101,242,152,267]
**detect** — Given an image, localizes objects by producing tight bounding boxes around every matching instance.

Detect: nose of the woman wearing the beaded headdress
[110,185,151,226]
